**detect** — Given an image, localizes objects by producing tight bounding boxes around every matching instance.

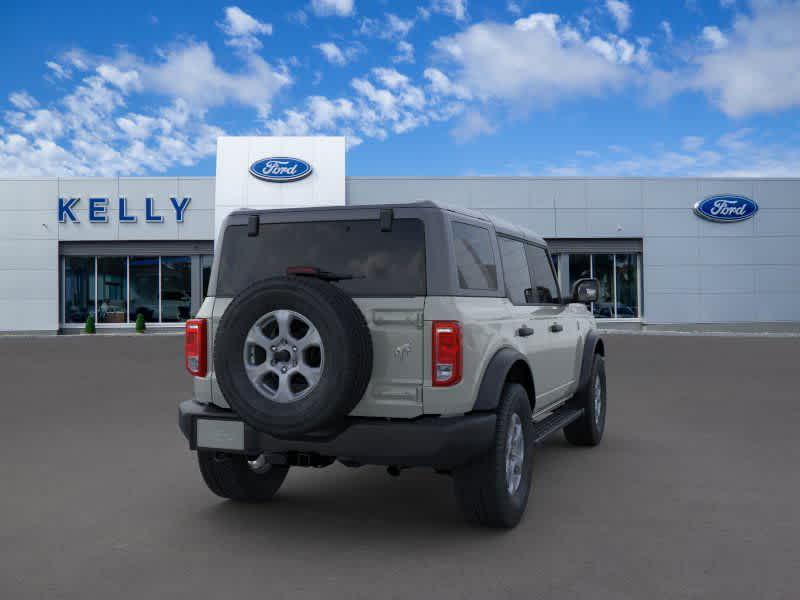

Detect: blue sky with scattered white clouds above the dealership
[0,0,800,176]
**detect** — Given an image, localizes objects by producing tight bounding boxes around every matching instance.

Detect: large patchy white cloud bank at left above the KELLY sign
[0,29,291,176]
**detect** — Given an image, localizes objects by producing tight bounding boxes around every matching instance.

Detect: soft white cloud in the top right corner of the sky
[692,1,800,117]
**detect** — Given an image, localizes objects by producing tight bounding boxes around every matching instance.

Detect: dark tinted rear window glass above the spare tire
[216,219,425,296]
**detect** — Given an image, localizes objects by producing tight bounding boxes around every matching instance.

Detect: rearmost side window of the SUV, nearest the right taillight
[453,223,497,290]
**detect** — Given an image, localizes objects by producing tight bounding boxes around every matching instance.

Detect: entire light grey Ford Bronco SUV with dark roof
[180,202,606,527]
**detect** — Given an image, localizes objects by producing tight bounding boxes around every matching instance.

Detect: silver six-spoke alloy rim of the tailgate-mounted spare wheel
[243,310,325,404]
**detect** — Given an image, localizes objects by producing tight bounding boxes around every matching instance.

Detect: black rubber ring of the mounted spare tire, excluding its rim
[214,277,372,437]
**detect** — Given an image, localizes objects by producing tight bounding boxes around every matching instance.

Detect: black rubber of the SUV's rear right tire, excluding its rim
[453,383,533,529]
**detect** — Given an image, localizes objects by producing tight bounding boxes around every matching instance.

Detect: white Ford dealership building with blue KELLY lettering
[0,137,800,333]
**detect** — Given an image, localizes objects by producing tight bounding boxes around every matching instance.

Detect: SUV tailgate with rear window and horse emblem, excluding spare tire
[209,216,427,418]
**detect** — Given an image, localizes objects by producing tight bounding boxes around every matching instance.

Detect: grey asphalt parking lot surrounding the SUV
[0,335,800,600]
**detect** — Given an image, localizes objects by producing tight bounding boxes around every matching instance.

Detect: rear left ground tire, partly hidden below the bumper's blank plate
[197,450,289,502]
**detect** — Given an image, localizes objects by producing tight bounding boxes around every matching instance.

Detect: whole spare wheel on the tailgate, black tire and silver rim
[214,276,372,437]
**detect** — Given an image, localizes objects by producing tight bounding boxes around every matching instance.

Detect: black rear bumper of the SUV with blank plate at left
[179,400,496,468]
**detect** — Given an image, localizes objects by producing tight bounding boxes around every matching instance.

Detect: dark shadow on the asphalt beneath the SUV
[190,465,502,544]
